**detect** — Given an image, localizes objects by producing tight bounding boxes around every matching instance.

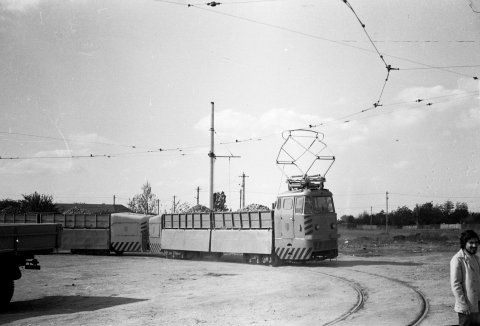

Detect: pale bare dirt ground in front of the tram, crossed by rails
[0,236,458,326]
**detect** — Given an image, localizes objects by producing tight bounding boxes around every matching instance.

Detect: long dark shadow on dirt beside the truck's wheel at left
[0,296,147,325]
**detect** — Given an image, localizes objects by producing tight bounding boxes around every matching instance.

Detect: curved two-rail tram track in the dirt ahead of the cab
[298,269,429,326]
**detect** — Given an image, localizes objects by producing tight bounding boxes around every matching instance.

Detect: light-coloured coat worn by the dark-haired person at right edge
[450,249,480,313]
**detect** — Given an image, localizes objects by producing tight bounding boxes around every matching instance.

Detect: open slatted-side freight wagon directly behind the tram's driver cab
[149,212,273,263]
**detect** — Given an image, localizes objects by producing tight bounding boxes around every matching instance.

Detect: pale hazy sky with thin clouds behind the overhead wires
[0,0,480,217]
